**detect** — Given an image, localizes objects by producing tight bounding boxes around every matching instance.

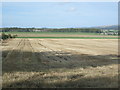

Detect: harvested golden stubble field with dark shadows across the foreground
[2,38,118,88]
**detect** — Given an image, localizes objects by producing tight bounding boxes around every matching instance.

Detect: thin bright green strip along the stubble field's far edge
[16,37,120,39]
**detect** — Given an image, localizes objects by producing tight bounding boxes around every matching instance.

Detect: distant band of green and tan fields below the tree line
[2,32,118,39]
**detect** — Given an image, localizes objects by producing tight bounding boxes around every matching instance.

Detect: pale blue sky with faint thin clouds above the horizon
[2,2,118,28]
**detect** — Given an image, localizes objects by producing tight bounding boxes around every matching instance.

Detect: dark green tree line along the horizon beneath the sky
[0,27,101,33]
